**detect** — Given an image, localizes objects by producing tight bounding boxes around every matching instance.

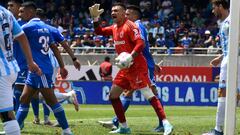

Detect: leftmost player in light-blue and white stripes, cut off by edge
[0,6,41,135]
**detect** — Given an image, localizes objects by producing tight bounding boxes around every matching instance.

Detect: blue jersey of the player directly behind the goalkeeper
[135,20,155,68]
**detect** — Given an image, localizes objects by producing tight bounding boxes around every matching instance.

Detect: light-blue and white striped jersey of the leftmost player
[0,6,23,76]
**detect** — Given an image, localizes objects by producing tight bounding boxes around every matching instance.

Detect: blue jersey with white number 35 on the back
[22,18,54,74]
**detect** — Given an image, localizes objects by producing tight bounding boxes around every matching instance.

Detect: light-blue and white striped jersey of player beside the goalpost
[219,16,230,57]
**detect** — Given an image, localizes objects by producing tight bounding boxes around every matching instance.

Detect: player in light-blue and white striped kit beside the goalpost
[203,0,240,135]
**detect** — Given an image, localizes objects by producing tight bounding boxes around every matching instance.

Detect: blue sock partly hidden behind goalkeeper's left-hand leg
[112,96,132,128]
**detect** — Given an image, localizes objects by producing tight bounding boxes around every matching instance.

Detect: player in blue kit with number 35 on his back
[16,2,72,135]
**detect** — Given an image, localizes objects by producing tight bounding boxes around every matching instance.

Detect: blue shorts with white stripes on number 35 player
[26,73,53,89]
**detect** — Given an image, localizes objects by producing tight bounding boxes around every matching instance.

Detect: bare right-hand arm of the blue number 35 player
[50,44,68,79]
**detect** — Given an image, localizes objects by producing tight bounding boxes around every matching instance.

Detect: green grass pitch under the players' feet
[0,105,240,135]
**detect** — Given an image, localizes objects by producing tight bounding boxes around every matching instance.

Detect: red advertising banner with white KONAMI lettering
[155,66,213,82]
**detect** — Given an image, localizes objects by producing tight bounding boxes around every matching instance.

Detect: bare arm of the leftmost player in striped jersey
[15,34,42,75]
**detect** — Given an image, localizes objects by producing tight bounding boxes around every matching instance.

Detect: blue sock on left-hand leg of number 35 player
[16,104,29,126]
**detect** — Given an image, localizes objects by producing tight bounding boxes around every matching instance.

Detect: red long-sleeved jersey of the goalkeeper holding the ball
[95,20,147,70]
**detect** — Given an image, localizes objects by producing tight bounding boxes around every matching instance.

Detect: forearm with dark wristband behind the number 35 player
[61,40,81,70]
